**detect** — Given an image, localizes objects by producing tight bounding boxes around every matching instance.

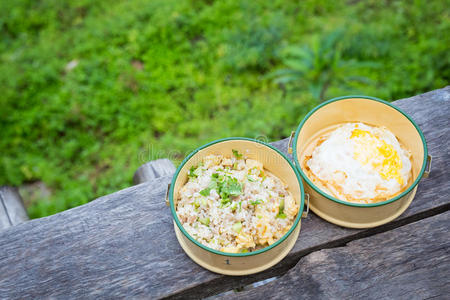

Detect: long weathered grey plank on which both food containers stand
[0,87,450,298]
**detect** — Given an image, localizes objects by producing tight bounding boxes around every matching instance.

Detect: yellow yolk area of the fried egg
[350,129,403,185]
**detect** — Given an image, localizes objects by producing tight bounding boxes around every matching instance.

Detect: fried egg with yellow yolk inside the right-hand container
[304,123,411,203]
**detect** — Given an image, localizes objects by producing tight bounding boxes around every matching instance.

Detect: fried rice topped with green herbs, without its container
[176,150,299,253]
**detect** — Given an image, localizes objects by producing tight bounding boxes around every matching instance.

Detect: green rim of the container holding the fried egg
[293,95,428,207]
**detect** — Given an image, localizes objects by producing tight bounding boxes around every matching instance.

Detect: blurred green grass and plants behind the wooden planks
[0,0,450,217]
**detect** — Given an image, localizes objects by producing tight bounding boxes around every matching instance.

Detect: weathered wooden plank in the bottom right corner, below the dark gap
[222,212,450,300]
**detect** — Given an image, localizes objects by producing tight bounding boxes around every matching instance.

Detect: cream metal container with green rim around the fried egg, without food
[289,96,431,228]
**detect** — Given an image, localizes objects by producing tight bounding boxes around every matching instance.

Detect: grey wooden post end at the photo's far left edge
[0,186,28,231]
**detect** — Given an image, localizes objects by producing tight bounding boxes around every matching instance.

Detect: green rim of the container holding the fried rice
[169,137,305,257]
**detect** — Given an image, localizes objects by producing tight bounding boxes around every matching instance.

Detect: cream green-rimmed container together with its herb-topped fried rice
[168,138,304,275]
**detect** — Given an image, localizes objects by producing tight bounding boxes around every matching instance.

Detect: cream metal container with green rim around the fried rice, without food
[168,138,304,275]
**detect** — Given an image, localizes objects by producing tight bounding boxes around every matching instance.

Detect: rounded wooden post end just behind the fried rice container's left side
[133,158,175,184]
